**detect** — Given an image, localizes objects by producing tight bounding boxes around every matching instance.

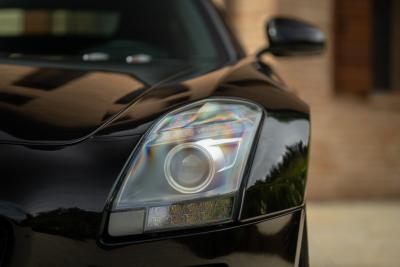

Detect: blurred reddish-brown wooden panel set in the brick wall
[334,0,373,95]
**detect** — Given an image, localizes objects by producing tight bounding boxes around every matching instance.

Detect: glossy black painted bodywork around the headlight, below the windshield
[0,1,310,266]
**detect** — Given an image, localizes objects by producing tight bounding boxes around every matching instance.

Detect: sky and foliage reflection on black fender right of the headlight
[240,112,310,220]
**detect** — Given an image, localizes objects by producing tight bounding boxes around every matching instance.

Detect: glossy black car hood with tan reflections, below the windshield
[0,59,206,144]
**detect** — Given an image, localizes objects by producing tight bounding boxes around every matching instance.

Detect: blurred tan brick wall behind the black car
[227,0,400,199]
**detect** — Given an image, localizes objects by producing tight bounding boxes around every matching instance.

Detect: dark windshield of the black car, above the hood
[0,0,227,63]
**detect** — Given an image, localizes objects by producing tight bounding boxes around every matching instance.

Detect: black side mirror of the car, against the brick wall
[258,18,326,57]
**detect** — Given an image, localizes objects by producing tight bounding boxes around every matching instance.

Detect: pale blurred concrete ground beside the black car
[307,201,400,267]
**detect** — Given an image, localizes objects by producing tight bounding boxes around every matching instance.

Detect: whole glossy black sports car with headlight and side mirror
[0,0,324,267]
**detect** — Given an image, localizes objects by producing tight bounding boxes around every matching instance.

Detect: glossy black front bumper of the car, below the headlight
[9,208,305,267]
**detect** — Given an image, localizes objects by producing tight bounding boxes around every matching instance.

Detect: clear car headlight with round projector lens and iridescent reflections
[108,99,262,236]
